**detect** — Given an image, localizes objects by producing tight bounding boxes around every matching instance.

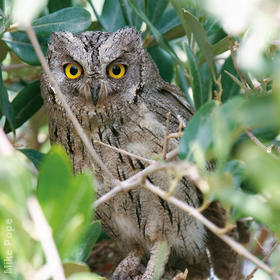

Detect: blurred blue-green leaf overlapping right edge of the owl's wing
[179,101,217,159]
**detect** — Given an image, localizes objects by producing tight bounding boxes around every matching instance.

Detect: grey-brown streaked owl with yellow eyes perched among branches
[41,27,246,280]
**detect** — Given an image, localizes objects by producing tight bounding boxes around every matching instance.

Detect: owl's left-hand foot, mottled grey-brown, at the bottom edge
[111,249,143,280]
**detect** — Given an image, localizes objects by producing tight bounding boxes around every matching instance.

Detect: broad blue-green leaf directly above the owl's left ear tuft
[32,7,91,37]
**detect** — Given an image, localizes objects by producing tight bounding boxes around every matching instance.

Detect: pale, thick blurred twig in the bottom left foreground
[27,197,65,280]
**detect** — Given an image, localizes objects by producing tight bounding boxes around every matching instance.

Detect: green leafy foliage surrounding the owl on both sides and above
[0,0,280,279]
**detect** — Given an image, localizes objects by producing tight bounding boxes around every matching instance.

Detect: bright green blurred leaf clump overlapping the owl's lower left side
[37,146,94,260]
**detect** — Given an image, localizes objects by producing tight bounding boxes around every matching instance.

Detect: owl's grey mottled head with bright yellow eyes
[42,28,162,106]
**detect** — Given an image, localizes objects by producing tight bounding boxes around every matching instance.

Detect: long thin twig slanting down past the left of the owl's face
[26,25,118,184]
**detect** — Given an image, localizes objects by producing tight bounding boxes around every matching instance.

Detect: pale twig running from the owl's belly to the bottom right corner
[145,180,280,280]
